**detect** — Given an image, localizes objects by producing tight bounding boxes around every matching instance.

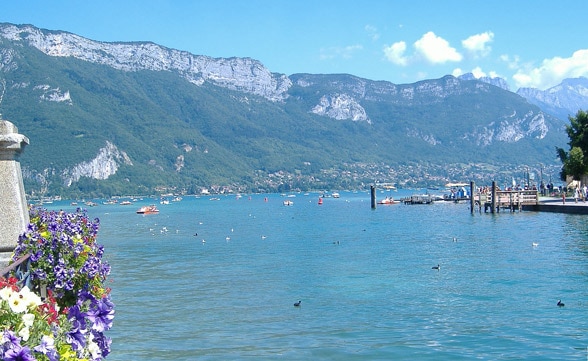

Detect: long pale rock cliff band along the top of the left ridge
[0,24,291,101]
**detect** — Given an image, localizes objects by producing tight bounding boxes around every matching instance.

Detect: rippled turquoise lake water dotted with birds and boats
[49,192,588,361]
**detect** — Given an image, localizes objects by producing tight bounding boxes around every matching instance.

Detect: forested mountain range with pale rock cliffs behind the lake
[0,23,588,196]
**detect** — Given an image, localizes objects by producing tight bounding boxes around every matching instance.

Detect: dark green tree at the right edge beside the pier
[556,110,588,180]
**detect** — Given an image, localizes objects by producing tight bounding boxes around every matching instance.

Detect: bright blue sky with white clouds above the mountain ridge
[0,0,588,91]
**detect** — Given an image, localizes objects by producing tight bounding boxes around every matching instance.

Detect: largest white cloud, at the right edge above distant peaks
[513,49,588,89]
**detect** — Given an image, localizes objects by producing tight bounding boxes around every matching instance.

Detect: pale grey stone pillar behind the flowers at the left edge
[0,120,29,252]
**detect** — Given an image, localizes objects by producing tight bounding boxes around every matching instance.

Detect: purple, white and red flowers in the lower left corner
[0,208,114,361]
